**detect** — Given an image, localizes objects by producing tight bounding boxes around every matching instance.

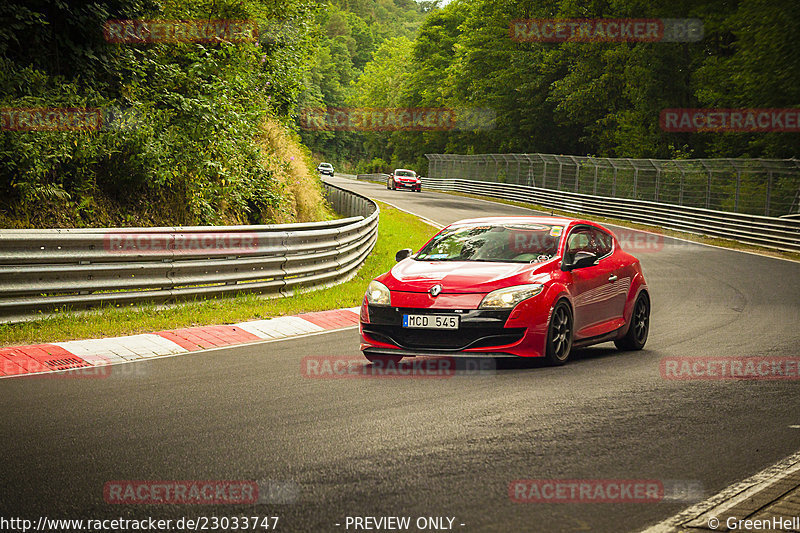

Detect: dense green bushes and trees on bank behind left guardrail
[0,0,320,226]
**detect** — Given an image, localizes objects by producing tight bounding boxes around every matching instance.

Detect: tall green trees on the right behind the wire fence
[302,0,800,172]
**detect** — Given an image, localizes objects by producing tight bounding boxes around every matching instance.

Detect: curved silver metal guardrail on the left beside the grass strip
[0,183,379,322]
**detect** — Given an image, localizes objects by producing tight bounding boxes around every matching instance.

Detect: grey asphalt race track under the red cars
[0,179,800,532]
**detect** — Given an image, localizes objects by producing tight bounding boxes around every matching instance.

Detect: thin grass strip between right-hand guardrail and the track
[437,191,800,261]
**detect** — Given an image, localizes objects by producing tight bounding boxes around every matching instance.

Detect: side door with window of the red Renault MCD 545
[565,226,619,338]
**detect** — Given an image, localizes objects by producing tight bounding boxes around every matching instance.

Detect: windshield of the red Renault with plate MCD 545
[415,224,564,263]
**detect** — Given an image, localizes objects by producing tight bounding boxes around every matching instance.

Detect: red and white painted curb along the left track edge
[0,307,359,377]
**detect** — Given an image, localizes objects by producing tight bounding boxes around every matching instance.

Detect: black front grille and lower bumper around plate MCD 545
[364,306,525,351]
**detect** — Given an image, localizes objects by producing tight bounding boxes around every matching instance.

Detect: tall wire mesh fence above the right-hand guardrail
[425,153,800,216]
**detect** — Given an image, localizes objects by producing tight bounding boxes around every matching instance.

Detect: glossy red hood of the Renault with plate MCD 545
[378,259,555,294]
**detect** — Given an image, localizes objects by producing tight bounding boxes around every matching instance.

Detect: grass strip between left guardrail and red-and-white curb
[0,202,437,346]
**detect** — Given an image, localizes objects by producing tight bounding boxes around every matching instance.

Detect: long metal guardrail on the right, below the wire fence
[422,178,800,252]
